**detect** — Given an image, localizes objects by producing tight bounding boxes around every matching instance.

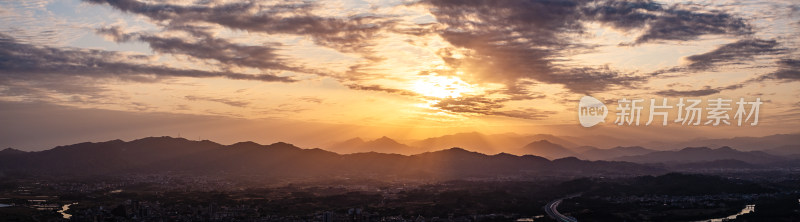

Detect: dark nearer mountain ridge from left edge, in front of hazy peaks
[0,137,663,179]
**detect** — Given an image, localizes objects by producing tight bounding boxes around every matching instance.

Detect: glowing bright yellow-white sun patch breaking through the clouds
[411,76,475,98]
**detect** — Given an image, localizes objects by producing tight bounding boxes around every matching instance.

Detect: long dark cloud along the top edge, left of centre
[84,0,391,51]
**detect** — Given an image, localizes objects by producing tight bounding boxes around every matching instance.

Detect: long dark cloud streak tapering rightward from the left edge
[0,34,295,82]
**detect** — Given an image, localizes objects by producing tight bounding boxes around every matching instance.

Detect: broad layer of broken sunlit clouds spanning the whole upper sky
[0,0,800,119]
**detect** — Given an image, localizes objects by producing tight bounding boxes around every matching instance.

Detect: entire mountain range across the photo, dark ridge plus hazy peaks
[0,134,800,179]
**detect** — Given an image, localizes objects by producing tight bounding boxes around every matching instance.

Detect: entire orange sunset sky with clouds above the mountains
[0,0,800,150]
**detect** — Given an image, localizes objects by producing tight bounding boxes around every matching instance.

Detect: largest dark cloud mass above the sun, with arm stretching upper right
[423,0,750,93]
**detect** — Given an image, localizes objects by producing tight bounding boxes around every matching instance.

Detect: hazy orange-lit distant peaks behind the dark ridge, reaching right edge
[324,132,800,160]
